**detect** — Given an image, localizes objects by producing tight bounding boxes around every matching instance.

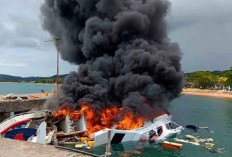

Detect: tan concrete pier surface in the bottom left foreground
[0,138,88,157]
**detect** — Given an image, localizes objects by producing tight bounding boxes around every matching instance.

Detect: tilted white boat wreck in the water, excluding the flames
[94,113,184,147]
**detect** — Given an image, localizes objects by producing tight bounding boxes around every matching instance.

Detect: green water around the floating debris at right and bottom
[75,96,232,157]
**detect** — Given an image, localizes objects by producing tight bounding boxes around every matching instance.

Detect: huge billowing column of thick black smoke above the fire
[41,0,183,116]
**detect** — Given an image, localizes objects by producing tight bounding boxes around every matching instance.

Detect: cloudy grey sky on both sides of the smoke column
[0,0,232,77]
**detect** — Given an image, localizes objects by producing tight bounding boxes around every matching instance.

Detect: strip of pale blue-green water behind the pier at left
[0,82,55,95]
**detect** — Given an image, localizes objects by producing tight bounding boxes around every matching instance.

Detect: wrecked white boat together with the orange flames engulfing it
[53,105,183,147]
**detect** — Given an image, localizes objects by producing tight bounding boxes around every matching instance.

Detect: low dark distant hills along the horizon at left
[0,74,68,81]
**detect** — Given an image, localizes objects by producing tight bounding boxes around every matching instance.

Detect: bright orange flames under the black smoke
[53,103,144,135]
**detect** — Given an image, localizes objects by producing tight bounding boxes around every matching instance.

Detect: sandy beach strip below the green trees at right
[182,88,232,100]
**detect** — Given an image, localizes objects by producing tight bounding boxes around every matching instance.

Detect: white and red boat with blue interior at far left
[0,111,55,144]
